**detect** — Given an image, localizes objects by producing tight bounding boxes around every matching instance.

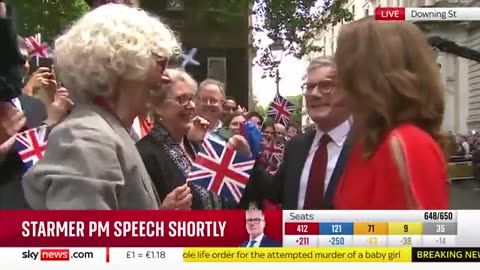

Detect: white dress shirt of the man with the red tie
[297,121,350,209]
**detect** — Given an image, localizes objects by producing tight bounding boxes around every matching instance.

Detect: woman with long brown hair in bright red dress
[334,18,449,209]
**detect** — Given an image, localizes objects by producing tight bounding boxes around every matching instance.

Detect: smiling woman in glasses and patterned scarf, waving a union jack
[137,69,253,210]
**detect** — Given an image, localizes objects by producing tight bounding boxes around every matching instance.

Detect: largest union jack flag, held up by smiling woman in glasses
[187,134,255,202]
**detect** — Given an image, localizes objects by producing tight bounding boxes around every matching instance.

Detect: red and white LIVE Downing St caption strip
[375,7,480,22]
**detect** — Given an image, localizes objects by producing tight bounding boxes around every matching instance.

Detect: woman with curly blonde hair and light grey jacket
[23,4,191,209]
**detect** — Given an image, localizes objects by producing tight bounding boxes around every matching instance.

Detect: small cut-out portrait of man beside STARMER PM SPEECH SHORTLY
[240,210,282,247]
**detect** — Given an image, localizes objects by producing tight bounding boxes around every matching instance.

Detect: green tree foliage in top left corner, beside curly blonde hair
[10,0,89,42]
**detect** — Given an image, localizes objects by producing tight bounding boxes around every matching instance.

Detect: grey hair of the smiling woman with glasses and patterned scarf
[150,69,198,104]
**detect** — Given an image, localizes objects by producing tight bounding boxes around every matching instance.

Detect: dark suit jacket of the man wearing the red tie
[243,130,351,210]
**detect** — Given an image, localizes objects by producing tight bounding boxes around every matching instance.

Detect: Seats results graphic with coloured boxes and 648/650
[283,210,480,247]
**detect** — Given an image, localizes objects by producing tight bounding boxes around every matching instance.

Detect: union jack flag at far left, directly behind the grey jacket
[14,125,47,169]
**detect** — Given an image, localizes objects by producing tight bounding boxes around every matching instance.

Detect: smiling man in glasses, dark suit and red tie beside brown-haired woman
[246,57,351,210]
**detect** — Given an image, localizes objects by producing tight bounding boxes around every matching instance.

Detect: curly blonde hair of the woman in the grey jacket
[54,4,181,102]
